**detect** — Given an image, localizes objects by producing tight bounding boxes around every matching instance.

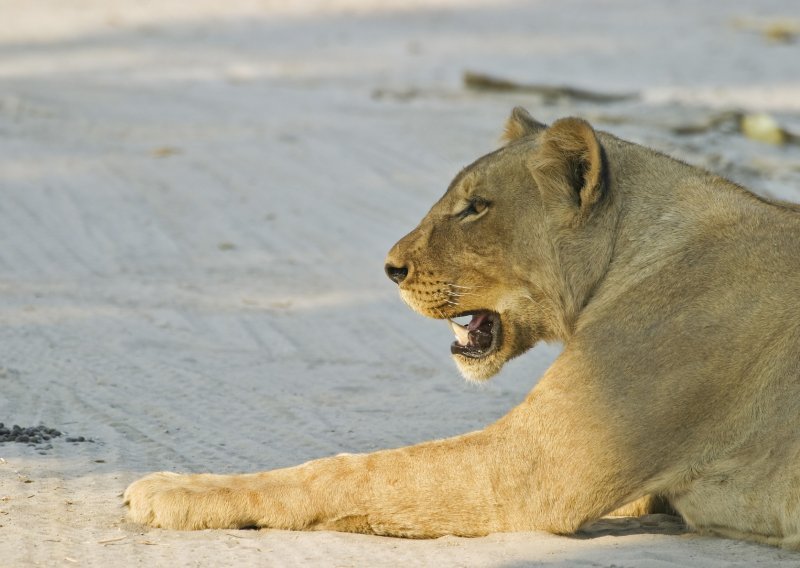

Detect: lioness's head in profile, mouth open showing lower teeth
[386,108,616,380]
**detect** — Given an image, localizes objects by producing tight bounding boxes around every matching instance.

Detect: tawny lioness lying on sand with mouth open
[125,108,800,548]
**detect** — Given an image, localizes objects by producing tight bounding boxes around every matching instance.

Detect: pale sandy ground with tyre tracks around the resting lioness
[0,0,800,567]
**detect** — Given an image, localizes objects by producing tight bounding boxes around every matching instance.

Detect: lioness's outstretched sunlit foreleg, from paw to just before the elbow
[125,432,508,537]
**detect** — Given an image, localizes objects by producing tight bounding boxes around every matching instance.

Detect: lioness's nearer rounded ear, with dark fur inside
[530,118,605,222]
